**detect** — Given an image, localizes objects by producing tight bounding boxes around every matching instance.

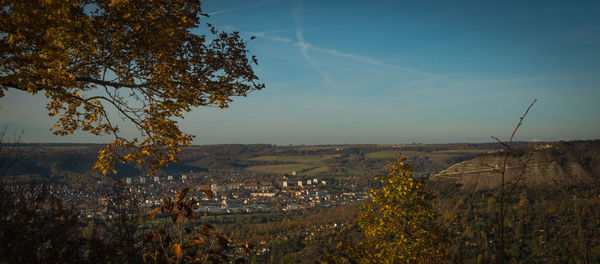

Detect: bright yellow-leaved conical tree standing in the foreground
[359,158,446,263]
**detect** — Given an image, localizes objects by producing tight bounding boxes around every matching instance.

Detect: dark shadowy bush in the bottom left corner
[0,184,86,263]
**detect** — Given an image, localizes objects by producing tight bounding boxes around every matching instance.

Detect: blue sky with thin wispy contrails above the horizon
[0,0,600,145]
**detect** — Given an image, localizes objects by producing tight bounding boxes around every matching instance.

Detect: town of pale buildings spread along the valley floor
[13,171,368,219]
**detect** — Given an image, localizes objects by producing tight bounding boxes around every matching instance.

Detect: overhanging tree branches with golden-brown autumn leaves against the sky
[0,0,264,174]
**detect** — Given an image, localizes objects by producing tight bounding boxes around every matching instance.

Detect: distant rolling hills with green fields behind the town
[0,143,498,188]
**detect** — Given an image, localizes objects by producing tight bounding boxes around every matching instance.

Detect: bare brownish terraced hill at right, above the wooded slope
[430,140,600,191]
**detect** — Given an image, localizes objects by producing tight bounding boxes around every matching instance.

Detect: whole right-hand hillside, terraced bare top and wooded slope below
[430,140,600,263]
